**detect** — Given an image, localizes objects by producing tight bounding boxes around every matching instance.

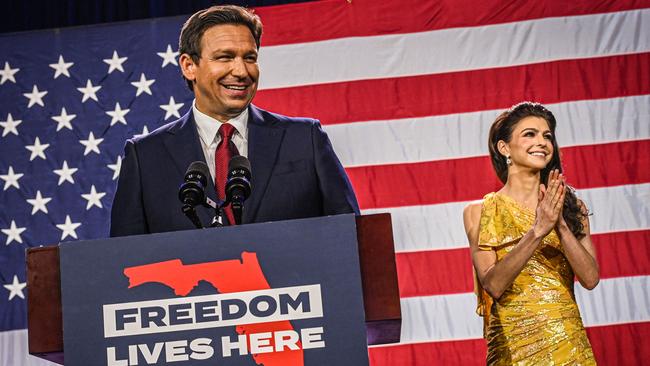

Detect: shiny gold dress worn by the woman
[475,193,596,365]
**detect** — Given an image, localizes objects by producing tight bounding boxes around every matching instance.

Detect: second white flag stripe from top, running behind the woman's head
[325,95,650,167]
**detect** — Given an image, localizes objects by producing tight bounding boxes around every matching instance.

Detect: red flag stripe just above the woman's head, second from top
[255,53,650,124]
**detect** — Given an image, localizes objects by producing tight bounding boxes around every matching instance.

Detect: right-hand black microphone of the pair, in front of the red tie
[226,155,251,225]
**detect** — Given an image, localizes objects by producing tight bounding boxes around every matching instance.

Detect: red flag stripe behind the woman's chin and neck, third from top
[346,139,650,209]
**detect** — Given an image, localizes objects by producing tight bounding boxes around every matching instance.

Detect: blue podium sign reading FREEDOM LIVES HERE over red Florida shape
[60,214,368,366]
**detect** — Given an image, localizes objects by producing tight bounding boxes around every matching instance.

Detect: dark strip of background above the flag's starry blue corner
[0,0,309,33]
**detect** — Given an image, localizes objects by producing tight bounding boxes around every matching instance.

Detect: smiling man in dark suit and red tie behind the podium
[111,6,359,236]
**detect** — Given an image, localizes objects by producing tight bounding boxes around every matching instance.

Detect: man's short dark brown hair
[178,5,262,90]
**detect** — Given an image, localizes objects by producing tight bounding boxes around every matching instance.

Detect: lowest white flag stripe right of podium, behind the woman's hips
[394,276,650,343]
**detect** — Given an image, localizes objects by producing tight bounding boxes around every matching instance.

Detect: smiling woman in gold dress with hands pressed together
[463,102,599,365]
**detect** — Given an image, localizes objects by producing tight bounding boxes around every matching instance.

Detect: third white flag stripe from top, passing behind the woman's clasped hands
[362,183,650,252]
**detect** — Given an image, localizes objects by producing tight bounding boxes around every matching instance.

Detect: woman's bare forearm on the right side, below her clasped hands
[555,201,600,290]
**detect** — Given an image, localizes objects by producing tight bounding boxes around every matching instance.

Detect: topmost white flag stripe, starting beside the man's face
[260,10,650,89]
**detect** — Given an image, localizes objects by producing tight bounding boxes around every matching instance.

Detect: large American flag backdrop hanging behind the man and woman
[0,0,650,366]
